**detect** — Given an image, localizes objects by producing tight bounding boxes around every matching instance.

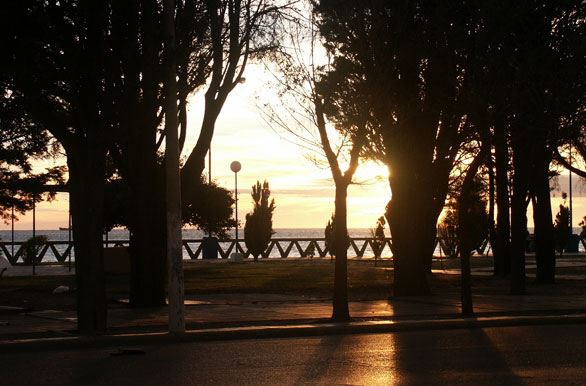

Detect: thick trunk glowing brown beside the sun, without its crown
[385,117,456,296]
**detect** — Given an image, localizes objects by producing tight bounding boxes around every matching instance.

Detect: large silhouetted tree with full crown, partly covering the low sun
[317,0,472,295]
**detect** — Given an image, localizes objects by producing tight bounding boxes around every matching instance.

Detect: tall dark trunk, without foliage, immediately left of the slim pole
[122,1,166,307]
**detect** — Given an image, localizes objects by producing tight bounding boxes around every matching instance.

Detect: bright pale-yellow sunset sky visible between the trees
[0,66,586,230]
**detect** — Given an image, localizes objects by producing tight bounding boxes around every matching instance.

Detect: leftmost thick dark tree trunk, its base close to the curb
[67,144,107,334]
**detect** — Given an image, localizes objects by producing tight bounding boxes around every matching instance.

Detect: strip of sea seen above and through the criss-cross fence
[0,228,584,262]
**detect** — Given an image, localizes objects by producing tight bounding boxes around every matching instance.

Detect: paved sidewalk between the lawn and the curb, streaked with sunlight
[0,260,586,347]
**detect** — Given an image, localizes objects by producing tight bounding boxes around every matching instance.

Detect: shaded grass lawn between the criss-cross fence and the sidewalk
[0,256,585,309]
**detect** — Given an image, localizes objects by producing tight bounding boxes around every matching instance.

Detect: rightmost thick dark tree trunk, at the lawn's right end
[532,141,556,284]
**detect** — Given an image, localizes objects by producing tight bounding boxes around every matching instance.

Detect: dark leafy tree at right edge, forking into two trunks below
[495,1,586,294]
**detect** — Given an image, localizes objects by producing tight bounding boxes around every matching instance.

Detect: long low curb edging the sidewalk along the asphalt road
[0,314,586,352]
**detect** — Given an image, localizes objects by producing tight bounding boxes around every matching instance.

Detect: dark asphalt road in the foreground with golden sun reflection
[0,325,586,386]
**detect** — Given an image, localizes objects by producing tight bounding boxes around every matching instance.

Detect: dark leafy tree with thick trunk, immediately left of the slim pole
[106,0,167,307]
